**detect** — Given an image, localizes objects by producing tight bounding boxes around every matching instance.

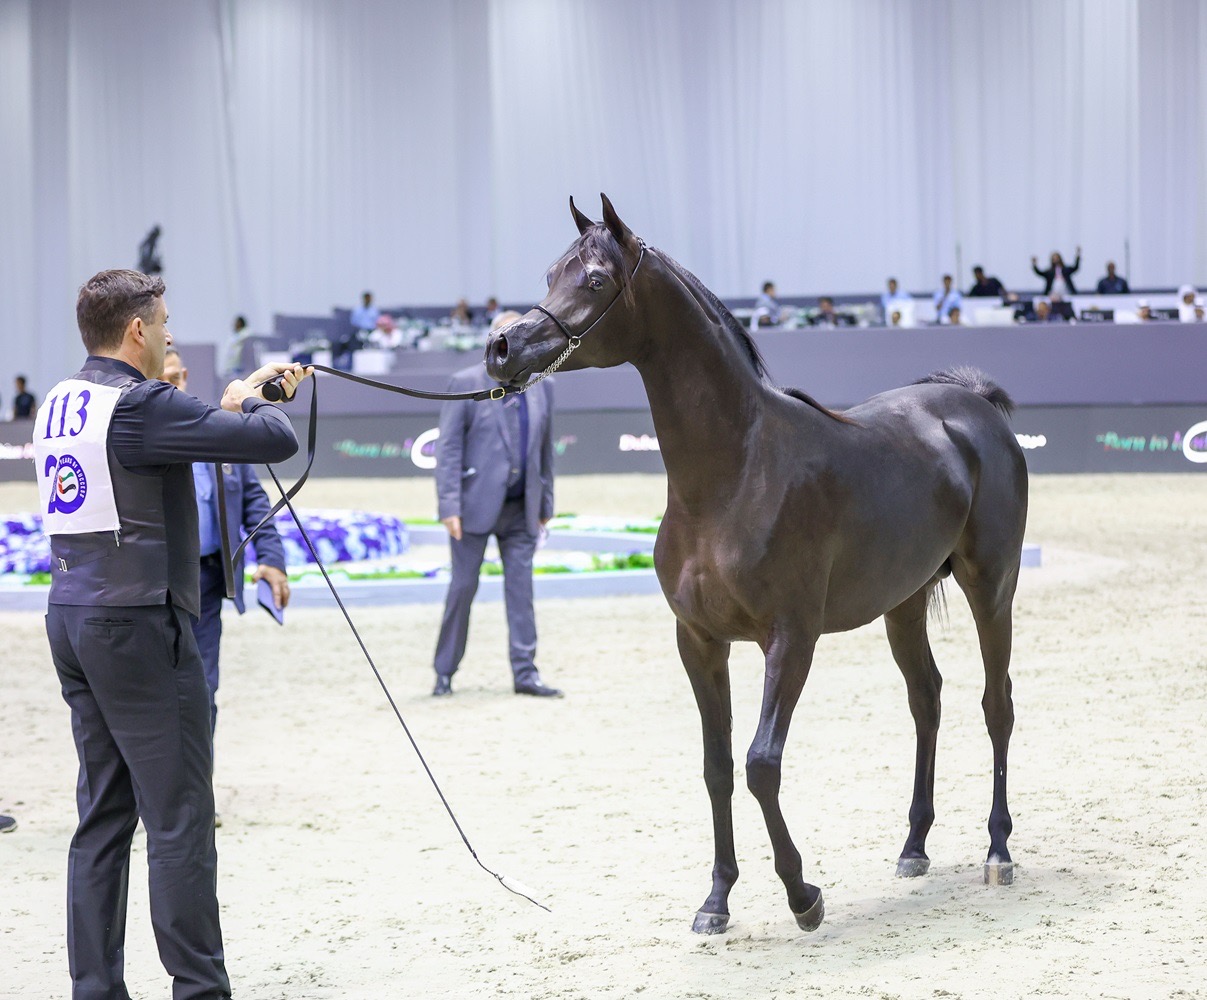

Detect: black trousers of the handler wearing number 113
[46,604,231,1000]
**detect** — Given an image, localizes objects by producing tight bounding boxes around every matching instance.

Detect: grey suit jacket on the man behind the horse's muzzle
[436,364,553,534]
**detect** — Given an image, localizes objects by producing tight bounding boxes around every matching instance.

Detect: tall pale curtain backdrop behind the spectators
[0,0,1207,404]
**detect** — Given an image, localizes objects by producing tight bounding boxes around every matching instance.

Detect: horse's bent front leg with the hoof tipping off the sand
[746,631,826,930]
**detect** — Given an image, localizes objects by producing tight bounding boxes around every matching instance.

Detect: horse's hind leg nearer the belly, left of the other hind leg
[885,584,943,877]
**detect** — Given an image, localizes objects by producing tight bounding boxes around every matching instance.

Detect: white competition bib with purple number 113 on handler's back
[34,379,122,534]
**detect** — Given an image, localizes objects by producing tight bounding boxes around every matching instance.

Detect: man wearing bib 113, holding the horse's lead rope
[34,270,310,1000]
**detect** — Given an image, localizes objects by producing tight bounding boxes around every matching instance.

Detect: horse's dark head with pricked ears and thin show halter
[485,194,645,385]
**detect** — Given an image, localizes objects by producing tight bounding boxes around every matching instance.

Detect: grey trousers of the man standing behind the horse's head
[435,499,537,683]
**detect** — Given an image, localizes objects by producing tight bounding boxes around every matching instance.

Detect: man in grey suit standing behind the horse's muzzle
[432,312,561,697]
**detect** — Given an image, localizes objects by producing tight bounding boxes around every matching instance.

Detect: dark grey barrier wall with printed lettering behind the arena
[0,323,1207,480]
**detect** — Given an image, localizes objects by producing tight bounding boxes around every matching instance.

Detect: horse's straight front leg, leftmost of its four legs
[677,621,737,934]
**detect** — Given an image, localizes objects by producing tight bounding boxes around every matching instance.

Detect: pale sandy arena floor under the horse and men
[0,475,1207,1000]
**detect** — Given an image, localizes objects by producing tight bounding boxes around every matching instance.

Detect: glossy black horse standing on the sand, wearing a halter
[486,197,1027,934]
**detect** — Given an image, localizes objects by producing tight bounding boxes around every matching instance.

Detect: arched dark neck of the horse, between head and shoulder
[634,262,770,503]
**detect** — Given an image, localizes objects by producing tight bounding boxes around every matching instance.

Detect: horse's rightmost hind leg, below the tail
[952,560,1019,884]
